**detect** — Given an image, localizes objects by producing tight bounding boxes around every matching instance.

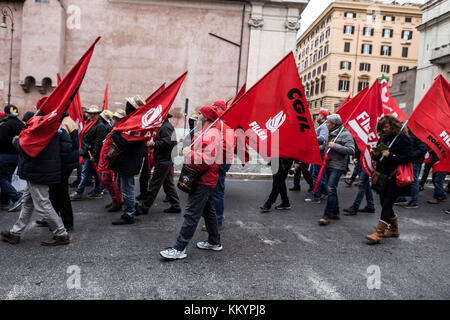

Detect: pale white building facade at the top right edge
[414,0,450,106]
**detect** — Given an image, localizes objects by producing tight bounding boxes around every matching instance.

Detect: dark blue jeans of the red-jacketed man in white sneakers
[173,184,220,251]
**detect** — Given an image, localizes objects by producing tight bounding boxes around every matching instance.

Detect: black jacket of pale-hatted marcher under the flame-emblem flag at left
[111,132,147,176]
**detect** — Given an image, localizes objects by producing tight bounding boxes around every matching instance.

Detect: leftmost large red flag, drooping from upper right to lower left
[19,37,100,157]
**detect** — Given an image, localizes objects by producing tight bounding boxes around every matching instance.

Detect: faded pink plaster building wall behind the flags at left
[0,0,307,126]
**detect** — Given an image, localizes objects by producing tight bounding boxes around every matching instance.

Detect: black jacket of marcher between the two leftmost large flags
[80,118,111,163]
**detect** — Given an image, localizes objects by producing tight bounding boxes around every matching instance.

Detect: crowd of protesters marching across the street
[0,96,450,259]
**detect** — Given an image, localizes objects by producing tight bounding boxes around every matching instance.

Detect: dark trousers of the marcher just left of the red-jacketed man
[142,161,180,208]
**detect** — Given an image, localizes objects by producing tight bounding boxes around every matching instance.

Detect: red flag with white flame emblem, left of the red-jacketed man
[113,71,187,141]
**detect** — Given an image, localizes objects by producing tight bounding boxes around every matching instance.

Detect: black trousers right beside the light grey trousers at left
[49,172,73,228]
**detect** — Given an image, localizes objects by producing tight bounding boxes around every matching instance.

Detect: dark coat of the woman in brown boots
[372,134,414,197]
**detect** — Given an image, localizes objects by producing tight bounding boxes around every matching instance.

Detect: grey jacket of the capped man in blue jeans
[326,126,355,170]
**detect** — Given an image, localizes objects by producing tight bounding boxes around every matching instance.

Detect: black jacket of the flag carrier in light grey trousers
[16,131,69,185]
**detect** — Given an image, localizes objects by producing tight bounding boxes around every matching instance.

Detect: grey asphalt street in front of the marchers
[0,177,450,300]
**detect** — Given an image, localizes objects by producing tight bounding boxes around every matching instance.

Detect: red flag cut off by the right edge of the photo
[408,75,450,160]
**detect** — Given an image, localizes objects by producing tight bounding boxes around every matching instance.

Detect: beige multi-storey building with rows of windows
[296,0,422,112]
